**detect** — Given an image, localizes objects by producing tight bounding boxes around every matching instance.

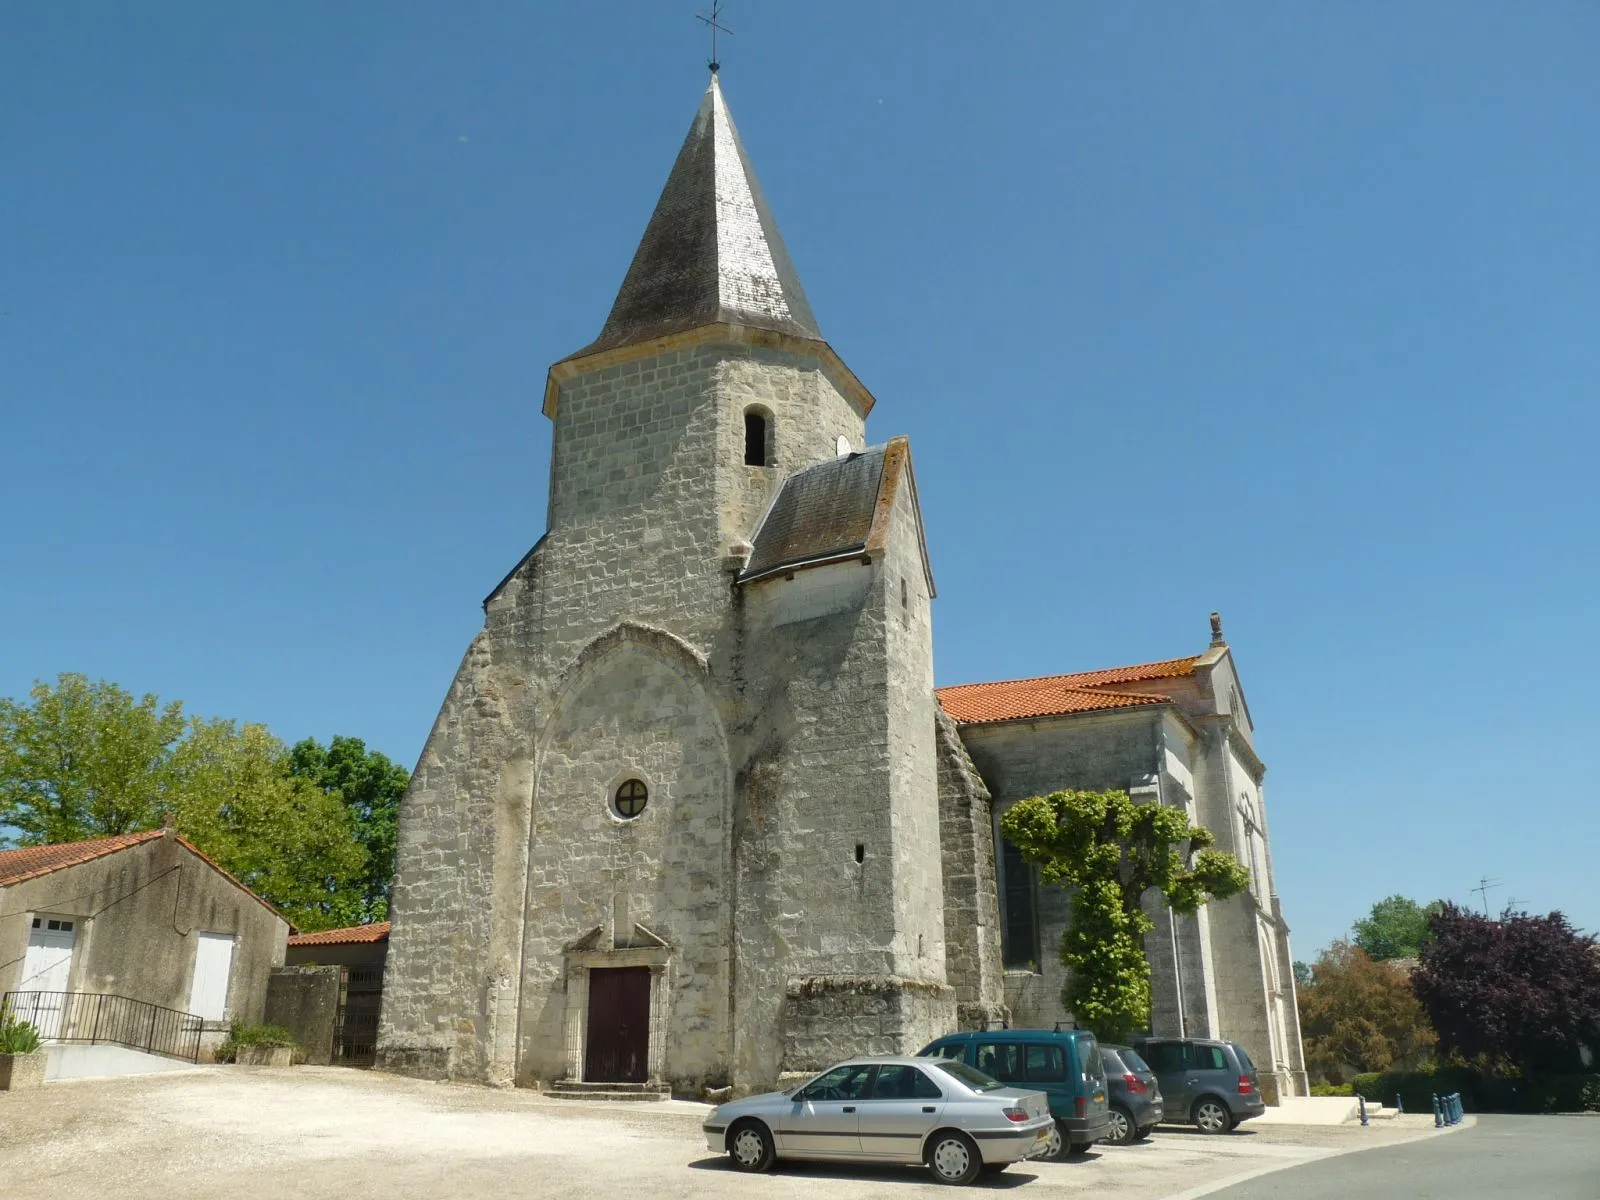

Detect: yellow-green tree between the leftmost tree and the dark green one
[173,720,366,931]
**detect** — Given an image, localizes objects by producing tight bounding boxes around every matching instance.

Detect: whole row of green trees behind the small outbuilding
[0,675,385,930]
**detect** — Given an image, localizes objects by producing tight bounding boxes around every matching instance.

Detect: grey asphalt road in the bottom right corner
[1208,1117,1600,1200]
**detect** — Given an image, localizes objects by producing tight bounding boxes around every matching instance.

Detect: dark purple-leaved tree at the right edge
[1411,902,1600,1075]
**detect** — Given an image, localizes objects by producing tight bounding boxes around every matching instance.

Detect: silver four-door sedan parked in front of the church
[702,1058,1054,1184]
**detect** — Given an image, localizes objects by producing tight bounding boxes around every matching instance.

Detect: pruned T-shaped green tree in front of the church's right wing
[1000,790,1250,1040]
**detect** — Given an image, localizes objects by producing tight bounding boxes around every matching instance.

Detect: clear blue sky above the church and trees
[0,0,1600,957]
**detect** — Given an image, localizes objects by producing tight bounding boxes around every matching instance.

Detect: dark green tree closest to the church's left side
[290,736,411,922]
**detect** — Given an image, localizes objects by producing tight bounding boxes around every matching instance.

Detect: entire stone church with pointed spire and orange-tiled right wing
[378,75,1304,1093]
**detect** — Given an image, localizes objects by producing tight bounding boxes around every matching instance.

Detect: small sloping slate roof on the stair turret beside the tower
[739,446,888,582]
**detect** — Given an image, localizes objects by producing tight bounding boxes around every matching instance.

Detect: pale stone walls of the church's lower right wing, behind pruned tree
[947,637,1306,1094]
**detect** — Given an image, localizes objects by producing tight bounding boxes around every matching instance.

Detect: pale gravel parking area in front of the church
[0,1067,1435,1200]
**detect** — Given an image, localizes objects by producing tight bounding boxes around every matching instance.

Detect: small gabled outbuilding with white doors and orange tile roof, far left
[0,829,290,1059]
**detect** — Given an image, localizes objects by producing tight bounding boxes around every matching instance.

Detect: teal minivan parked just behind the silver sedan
[920,1029,1110,1158]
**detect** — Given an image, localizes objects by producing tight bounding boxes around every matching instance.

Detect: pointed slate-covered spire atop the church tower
[573,75,822,357]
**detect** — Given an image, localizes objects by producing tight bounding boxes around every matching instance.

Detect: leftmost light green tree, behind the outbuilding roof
[0,674,184,845]
